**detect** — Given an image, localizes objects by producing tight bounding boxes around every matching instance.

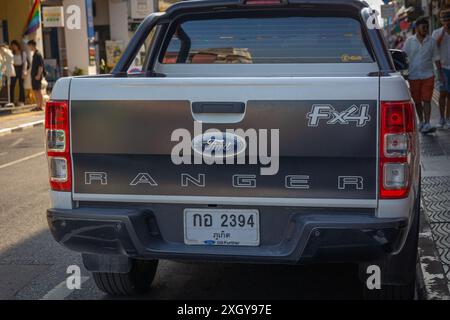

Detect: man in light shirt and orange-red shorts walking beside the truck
[403,17,442,133]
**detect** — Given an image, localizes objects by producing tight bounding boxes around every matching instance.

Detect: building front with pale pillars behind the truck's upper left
[42,0,158,81]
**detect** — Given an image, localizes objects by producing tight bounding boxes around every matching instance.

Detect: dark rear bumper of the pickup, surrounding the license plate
[47,206,408,264]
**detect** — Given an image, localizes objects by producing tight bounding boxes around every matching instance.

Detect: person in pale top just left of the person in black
[10,40,28,106]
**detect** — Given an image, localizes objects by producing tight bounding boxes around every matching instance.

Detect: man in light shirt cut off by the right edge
[432,8,450,129]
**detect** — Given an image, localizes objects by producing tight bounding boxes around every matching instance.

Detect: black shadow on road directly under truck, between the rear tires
[104,261,361,300]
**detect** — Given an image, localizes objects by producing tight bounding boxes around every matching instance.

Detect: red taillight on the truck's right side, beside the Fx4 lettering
[380,101,416,199]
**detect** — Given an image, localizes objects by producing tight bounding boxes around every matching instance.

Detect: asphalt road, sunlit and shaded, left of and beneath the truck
[0,127,361,299]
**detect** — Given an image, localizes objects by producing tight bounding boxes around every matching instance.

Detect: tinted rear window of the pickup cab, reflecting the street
[160,17,373,64]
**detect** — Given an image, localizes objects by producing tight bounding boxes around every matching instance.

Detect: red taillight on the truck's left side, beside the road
[45,101,72,191]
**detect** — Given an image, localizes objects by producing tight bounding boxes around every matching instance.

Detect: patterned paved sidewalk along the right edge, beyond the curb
[420,95,450,298]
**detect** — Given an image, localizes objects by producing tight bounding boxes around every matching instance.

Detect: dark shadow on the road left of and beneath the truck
[0,225,361,300]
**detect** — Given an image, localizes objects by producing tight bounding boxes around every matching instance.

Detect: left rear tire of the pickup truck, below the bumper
[92,259,158,296]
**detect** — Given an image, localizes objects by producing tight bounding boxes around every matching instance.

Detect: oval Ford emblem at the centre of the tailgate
[192,131,247,158]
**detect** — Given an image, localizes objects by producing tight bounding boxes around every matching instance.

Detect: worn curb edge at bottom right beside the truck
[417,202,450,300]
